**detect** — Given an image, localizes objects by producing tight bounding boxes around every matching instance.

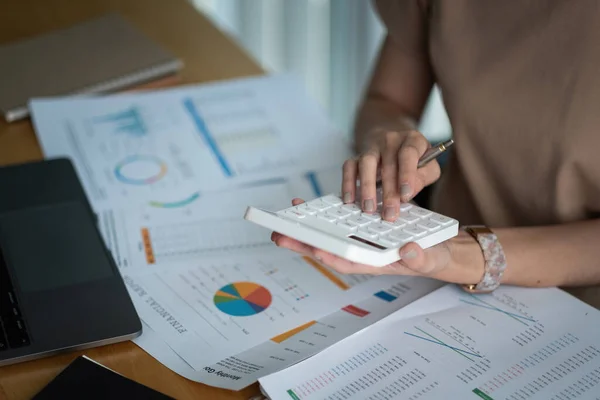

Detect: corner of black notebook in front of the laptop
[33,356,171,400]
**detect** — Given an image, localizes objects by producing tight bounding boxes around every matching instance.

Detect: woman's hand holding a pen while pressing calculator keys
[342,129,440,221]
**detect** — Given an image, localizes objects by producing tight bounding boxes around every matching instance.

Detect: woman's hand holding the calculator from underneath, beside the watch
[271,199,484,283]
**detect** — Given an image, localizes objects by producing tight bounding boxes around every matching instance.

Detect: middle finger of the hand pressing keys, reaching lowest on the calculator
[381,132,402,221]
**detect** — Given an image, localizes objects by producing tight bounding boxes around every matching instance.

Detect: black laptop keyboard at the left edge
[0,250,30,351]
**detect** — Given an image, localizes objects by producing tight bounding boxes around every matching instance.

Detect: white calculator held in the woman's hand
[244,194,458,267]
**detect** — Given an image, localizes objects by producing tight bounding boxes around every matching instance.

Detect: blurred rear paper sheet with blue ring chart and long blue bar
[30,76,350,206]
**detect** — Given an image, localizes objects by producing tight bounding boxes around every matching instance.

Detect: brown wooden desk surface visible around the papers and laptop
[0,0,263,400]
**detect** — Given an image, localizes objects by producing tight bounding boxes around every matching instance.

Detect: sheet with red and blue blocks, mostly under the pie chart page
[134,276,441,390]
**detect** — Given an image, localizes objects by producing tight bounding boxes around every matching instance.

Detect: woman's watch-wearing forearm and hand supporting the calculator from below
[392,220,600,287]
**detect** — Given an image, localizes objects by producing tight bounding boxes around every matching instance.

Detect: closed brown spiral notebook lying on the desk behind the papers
[0,13,183,122]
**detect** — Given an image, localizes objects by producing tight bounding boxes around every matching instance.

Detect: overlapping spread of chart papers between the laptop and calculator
[30,76,439,389]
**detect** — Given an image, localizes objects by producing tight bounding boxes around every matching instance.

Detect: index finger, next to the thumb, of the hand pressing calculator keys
[398,131,430,202]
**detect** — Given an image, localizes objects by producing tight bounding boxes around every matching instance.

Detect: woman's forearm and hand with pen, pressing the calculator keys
[342,35,440,216]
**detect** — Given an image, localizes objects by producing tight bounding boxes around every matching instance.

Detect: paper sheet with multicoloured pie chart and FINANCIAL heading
[123,250,420,369]
